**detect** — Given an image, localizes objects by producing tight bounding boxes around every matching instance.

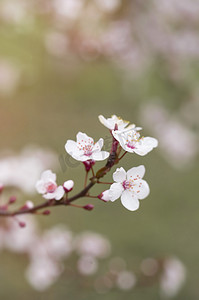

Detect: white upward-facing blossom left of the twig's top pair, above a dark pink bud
[65,132,109,161]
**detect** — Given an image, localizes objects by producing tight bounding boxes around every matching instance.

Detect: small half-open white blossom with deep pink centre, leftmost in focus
[36,170,64,200]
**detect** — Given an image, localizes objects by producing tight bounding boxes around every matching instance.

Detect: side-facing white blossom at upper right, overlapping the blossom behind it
[112,127,158,156]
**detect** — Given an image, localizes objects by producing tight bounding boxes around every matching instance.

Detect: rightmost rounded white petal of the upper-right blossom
[134,137,158,156]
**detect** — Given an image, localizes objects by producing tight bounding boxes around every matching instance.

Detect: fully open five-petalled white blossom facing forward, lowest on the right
[109,166,149,211]
